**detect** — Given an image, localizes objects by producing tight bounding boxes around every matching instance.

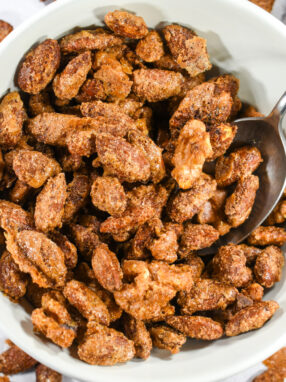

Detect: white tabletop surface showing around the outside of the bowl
[0,0,286,382]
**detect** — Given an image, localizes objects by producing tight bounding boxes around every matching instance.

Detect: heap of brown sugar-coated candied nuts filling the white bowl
[0,11,286,365]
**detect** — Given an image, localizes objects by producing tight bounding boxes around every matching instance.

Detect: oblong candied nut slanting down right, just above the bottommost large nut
[63,280,110,325]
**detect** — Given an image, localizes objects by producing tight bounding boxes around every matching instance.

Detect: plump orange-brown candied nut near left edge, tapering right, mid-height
[13,150,61,188]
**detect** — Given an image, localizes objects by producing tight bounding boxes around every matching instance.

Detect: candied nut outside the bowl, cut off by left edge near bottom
[0,340,37,375]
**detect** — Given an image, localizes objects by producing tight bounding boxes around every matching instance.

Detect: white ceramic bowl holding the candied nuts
[0,0,286,382]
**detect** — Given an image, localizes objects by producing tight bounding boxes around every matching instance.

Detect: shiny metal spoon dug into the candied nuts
[202,92,286,254]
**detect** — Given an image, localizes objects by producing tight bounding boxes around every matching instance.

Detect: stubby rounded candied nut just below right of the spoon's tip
[212,244,252,288]
